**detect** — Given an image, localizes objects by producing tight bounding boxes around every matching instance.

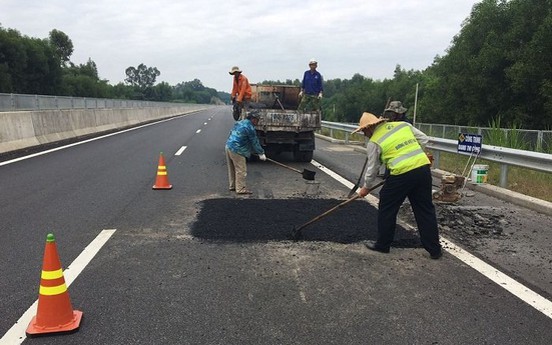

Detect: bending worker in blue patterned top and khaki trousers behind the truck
[225,110,266,194]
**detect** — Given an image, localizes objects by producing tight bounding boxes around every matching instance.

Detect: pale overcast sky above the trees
[0,0,480,92]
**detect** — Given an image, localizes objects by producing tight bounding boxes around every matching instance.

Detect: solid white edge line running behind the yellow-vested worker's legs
[312,160,552,319]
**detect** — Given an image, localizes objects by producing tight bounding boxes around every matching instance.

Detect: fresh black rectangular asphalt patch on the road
[191,198,421,248]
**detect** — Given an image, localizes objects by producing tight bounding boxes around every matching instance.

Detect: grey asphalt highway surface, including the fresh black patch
[0,107,552,344]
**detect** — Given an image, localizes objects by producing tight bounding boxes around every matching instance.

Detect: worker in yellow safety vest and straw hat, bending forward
[353,113,442,259]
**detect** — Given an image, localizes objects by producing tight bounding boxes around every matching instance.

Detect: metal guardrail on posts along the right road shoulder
[322,121,552,188]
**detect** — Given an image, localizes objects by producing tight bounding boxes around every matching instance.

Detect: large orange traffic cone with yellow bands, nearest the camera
[26,234,82,336]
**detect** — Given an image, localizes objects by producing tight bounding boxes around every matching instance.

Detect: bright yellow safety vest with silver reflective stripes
[370,122,431,175]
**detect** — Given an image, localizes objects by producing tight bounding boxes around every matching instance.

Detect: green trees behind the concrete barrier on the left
[0,25,226,104]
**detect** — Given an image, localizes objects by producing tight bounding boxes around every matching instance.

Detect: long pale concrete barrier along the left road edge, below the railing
[0,104,212,154]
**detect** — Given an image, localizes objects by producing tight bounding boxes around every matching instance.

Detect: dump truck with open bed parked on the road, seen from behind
[251,84,322,162]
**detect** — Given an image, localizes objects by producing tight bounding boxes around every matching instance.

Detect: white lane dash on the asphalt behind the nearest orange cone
[0,229,116,345]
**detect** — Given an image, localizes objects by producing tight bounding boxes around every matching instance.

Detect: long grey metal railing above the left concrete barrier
[0,93,185,112]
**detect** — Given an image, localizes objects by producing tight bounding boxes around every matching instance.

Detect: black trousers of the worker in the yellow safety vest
[376,165,441,255]
